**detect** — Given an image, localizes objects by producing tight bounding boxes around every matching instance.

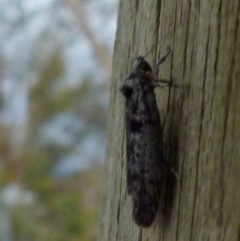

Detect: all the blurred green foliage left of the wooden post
[0,48,106,241]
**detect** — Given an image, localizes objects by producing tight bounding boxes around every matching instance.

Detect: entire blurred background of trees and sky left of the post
[0,0,117,241]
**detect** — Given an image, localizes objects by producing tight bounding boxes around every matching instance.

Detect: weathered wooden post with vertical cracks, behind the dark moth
[99,0,240,241]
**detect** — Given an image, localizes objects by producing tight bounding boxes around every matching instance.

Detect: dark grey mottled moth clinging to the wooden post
[120,48,171,227]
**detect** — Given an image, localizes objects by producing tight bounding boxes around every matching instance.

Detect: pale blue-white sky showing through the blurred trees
[0,0,117,175]
